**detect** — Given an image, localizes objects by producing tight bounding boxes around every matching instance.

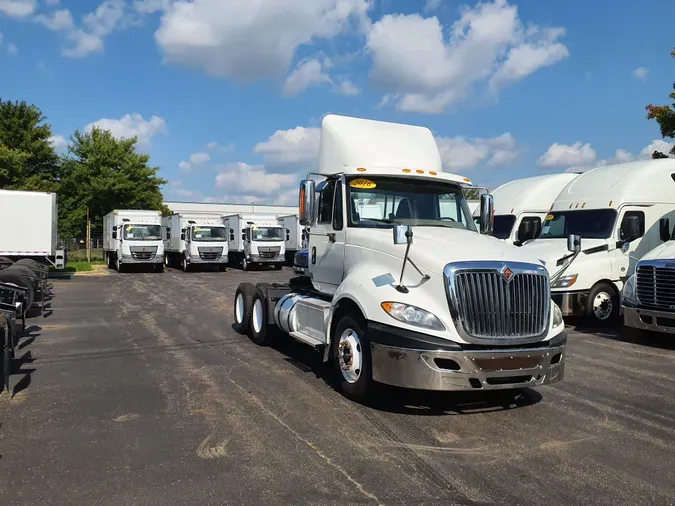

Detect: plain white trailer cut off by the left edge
[0,190,65,269]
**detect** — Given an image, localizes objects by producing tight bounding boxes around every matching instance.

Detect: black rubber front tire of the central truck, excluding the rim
[331,314,375,402]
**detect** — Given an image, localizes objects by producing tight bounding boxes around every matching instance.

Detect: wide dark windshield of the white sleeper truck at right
[539,209,616,239]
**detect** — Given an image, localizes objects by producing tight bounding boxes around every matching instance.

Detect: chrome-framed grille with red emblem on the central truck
[446,262,551,341]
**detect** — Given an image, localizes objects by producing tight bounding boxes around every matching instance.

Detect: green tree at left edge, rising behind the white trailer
[0,98,60,191]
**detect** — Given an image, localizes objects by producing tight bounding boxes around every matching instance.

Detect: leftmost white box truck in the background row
[103,209,164,272]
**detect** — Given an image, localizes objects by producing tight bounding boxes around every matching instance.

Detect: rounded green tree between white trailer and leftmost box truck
[59,128,166,237]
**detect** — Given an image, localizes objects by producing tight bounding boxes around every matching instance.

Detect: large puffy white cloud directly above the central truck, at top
[366,0,568,114]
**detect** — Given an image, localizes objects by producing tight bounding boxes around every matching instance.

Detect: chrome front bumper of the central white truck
[371,341,566,391]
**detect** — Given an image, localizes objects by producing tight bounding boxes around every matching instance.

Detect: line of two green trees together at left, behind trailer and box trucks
[0,98,167,238]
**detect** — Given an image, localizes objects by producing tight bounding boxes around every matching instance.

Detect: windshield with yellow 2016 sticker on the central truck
[347,176,476,231]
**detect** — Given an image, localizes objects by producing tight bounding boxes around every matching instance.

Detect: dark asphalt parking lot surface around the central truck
[0,269,675,505]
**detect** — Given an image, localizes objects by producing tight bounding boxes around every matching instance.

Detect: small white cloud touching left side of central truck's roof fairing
[253,126,321,172]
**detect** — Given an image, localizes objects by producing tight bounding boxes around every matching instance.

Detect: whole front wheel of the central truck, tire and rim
[331,315,374,402]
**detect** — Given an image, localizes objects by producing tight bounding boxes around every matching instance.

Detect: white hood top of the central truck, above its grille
[347,226,541,274]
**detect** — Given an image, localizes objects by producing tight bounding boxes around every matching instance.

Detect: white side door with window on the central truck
[309,179,345,292]
